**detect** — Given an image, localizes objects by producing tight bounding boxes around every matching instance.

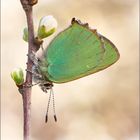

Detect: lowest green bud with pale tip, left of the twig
[11,68,24,85]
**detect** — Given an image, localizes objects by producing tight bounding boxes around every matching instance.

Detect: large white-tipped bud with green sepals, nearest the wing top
[37,16,57,39]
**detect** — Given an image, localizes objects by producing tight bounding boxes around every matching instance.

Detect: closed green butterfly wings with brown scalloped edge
[40,19,119,83]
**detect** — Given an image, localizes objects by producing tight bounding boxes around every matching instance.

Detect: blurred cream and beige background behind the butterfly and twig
[1,0,139,140]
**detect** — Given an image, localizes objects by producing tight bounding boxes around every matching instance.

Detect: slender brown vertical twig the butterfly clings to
[19,0,39,140]
